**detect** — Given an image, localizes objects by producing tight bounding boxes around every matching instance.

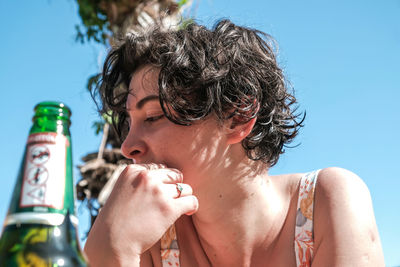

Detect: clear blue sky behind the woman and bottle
[0,0,400,266]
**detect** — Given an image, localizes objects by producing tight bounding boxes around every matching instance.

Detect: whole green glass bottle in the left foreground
[0,102,86,267]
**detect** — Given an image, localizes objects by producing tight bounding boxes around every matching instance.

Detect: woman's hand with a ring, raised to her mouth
[85,164,198,266]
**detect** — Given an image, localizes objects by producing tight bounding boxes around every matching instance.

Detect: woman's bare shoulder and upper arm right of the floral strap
[313,167,384,266]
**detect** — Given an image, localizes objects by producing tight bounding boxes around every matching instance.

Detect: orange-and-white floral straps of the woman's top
[161,170,319,267]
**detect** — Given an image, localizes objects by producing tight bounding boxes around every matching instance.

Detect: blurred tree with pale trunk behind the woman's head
[76,0,194,230]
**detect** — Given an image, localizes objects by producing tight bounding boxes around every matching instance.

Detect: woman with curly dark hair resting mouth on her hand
[85,20,384,266]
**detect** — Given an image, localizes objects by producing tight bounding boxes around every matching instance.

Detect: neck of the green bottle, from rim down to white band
[5,102,77,225]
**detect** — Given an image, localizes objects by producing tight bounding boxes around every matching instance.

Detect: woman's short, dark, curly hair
[94,20,305,166]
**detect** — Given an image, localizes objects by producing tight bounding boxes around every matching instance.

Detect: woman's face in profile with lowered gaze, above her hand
[121,65,227,187]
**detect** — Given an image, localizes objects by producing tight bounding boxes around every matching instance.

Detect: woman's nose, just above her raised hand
[121,128,146,163]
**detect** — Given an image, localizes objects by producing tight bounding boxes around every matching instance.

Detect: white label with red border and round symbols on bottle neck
[19,132,68,211]
